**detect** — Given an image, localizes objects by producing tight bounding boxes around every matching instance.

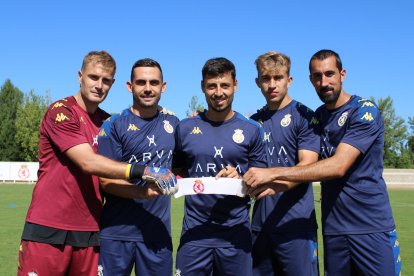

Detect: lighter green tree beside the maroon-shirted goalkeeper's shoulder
[15,90,51,161]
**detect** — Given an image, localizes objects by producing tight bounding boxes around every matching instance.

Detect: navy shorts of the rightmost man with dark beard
[323,230,402,275]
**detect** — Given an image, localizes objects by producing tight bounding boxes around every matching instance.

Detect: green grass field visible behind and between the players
[0,184,414,276]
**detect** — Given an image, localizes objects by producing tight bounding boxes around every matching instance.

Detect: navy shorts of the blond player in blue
[252,231,319,276]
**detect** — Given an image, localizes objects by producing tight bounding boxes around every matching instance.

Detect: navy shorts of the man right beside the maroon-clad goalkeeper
[99,239,173,275]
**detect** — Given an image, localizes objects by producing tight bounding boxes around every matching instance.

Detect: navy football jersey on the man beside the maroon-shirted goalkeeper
[98,109,179,242]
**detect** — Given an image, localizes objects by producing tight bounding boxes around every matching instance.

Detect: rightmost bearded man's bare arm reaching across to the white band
[243,143,360,193]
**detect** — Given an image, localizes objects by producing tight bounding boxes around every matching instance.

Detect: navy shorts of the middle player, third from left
[175,243,252,276]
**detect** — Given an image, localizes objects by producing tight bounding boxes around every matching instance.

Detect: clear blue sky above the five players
[0,0,414,120]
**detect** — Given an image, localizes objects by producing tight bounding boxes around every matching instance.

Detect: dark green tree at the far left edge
[0,80,23,161]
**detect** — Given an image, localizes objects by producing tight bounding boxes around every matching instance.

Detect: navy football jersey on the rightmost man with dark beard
[316,95,395,235]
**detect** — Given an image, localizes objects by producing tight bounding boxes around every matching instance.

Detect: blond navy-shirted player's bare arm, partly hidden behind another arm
[249,150,319,199]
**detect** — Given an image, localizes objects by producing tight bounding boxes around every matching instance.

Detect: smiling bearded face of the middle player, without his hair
[202,72,237,112]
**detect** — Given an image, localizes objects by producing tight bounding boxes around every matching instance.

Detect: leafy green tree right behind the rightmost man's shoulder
[371,96,411,168]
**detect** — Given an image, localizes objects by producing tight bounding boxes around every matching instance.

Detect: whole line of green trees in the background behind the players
[0,80,414,168]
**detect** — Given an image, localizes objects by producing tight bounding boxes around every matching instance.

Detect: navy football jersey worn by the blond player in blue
[251,100,320,233]
